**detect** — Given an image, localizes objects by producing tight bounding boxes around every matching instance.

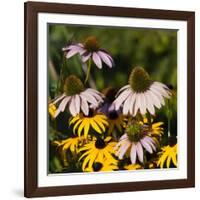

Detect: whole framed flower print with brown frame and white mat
[24,2,195,197]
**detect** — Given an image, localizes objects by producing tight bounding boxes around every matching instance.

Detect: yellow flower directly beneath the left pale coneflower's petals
[69,109,109,138]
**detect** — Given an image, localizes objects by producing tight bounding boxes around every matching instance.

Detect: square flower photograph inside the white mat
[46,23,179,174]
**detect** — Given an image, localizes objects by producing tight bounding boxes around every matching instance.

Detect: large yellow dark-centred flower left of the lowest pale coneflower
[79,137,116,171]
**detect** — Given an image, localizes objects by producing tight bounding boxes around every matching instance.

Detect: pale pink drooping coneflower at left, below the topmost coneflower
[52,75,103,117]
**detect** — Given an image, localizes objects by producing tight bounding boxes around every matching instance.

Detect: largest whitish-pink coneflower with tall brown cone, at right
[113,67,170,116]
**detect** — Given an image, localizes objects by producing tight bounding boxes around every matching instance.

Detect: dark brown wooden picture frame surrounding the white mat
[24,2,195,197]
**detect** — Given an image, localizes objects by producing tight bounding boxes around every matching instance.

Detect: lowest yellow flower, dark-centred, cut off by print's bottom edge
[85,159,118,172]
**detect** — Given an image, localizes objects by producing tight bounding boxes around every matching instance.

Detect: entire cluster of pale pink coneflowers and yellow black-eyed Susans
[49,37,177,172]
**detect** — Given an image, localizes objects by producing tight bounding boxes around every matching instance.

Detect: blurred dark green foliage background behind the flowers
[48,24,177,173]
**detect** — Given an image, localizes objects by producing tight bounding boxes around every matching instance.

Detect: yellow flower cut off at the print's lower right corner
[157,137,177,168]
